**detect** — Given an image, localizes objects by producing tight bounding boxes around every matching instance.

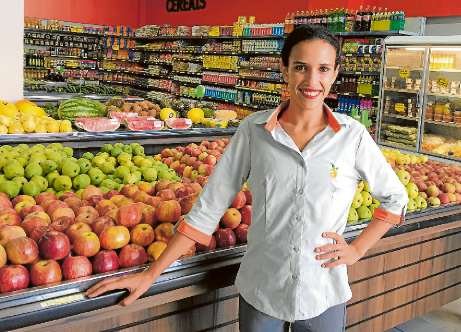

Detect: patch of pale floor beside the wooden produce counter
[387,299,461,332]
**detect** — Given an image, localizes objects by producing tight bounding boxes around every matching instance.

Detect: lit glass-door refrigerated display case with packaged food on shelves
[378,36,461,161]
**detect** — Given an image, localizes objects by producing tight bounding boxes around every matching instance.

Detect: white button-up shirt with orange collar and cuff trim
[177,105,408,321]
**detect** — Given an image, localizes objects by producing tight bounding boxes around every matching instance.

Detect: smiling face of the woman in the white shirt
[282,39,339,110]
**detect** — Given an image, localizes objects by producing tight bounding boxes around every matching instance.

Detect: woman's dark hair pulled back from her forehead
[282,24,341,68]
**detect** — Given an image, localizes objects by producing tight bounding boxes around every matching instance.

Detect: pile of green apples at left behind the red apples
[0,143,180,198]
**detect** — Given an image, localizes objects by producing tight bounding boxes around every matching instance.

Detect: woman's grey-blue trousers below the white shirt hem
[239,296,346,332]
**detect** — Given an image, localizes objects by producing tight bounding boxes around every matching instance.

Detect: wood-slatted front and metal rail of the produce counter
[0,205,461,331]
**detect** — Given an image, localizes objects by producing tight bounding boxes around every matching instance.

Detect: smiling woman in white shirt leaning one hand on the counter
[87,25,408,332]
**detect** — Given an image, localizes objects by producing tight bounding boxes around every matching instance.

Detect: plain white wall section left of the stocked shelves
[0,0,24,101]
